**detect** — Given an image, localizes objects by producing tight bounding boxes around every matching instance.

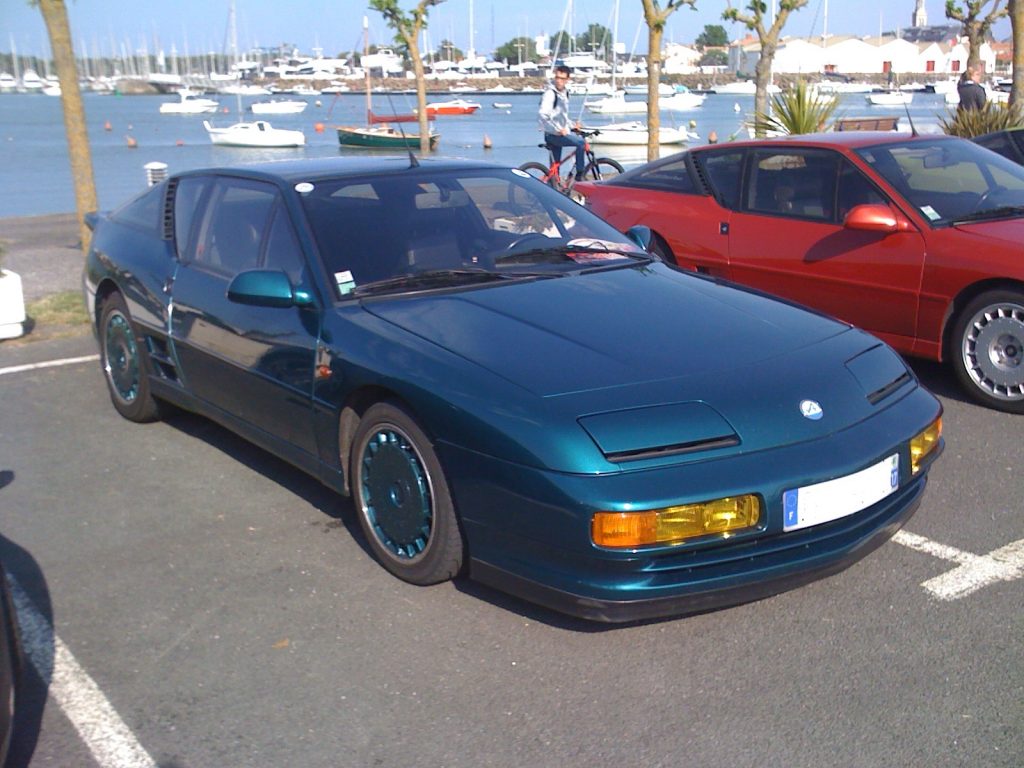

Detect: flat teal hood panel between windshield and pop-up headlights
[366,265,846,397]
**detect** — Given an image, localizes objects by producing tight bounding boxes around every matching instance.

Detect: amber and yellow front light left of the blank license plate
[591,495,761,548]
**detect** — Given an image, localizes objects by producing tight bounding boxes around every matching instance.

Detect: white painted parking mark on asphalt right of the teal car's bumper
[893,530,1024,600]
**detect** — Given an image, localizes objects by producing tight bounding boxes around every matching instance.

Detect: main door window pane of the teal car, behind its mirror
[194,178,278,276]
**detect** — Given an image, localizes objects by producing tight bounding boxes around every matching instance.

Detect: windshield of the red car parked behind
[857,137,1024,226]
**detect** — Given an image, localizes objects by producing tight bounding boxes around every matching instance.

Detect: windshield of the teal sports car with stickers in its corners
[296,167,647,298]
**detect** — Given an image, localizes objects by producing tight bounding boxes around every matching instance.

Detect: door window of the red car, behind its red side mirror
[745,150,838,221]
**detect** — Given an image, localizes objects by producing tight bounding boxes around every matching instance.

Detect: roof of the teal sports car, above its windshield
[175,155,504,183]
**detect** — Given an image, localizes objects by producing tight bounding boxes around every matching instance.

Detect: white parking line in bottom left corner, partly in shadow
[7,574,157,768]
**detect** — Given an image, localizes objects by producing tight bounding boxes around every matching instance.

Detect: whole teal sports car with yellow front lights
[84,157,943,622]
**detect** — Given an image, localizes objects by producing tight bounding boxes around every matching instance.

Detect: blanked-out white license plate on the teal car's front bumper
[782,454,899,530]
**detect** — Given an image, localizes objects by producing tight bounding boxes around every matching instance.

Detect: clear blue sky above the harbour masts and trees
[0,0,1010,55]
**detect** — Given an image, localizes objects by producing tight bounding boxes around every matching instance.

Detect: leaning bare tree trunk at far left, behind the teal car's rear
[39,0,98,253]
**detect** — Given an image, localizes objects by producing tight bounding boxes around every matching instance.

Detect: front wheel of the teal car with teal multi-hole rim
[350,402,464,585]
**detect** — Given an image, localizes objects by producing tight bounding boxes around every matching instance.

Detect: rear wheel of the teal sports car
[99,293,160,423]
